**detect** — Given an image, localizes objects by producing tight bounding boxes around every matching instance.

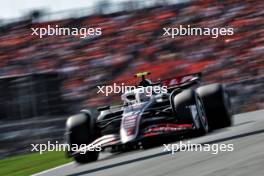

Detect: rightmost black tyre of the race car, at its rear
[197,84,232,129]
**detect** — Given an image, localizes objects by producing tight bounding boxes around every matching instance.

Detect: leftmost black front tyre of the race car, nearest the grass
[66,113,99,163]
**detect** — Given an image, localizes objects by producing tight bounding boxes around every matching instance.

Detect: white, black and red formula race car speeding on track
[66,72,232,163]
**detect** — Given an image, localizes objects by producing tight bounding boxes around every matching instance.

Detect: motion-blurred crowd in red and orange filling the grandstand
[0,0,264,113]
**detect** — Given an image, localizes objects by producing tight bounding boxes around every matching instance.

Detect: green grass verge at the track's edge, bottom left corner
[0,152,72,176]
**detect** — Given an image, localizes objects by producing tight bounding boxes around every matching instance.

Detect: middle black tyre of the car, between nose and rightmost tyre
[173,89,209,136]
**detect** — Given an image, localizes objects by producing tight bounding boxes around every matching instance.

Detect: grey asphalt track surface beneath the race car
[35,110,264,176]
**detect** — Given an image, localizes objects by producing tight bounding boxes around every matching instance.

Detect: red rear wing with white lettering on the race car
[161,72,202,88]
